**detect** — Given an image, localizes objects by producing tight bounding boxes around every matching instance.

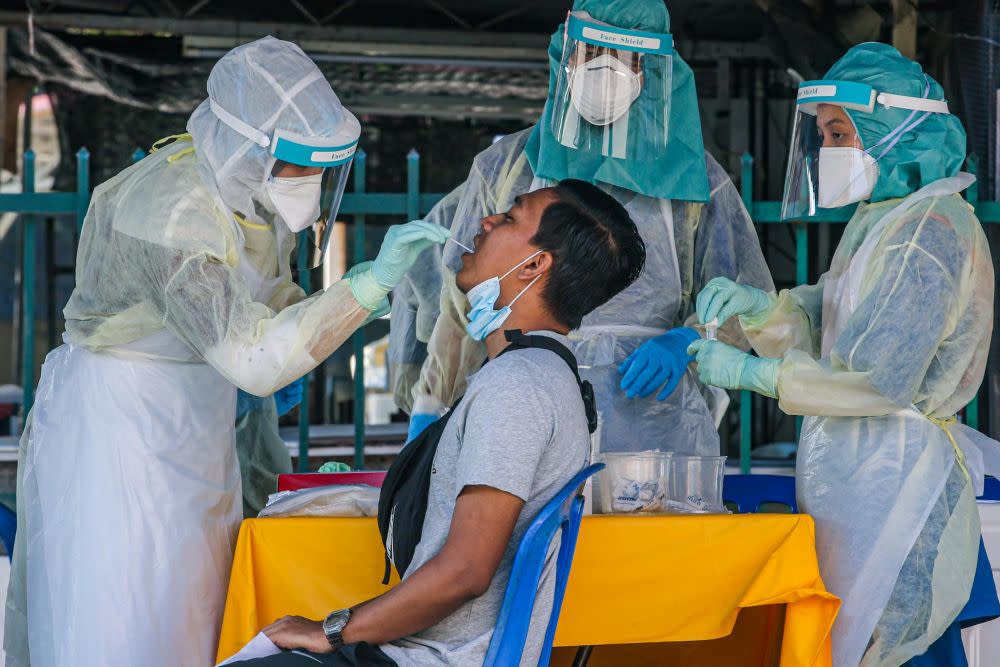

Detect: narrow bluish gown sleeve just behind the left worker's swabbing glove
[388,183,465,414]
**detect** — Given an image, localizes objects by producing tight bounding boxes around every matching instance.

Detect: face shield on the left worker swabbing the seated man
[211,101,361,268]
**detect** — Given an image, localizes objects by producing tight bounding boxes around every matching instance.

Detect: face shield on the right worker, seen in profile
[781,81,948,220]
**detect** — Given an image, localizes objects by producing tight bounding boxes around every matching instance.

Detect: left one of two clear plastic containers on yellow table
[594,451,671,514]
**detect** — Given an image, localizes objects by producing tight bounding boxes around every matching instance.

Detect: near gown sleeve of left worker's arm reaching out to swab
[133,236,369,396]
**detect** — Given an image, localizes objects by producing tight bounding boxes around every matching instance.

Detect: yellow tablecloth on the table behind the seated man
[219,514,840,667]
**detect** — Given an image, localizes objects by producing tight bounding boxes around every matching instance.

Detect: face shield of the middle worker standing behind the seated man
[551,13,673,160]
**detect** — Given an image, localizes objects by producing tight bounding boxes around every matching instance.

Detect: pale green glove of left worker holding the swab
[350,220,451,310]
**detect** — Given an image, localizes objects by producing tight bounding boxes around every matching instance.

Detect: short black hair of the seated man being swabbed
[531,179,646,329]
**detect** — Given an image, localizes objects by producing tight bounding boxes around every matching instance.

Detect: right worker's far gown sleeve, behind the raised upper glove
[733,274,826,357]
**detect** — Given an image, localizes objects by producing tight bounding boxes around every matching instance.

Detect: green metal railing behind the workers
[0,149,1000,473]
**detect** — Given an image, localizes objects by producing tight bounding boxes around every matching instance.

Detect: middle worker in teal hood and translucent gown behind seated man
[389,0,772,454]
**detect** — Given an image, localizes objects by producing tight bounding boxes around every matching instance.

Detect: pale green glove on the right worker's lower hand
[688,340,781,398]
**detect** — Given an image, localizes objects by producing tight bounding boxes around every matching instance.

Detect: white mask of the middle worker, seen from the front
[569,54,642,126]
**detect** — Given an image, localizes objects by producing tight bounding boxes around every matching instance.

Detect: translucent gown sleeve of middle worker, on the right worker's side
[692,156,774,351]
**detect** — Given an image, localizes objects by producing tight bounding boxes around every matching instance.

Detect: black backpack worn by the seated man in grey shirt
[378,330,597,584]
